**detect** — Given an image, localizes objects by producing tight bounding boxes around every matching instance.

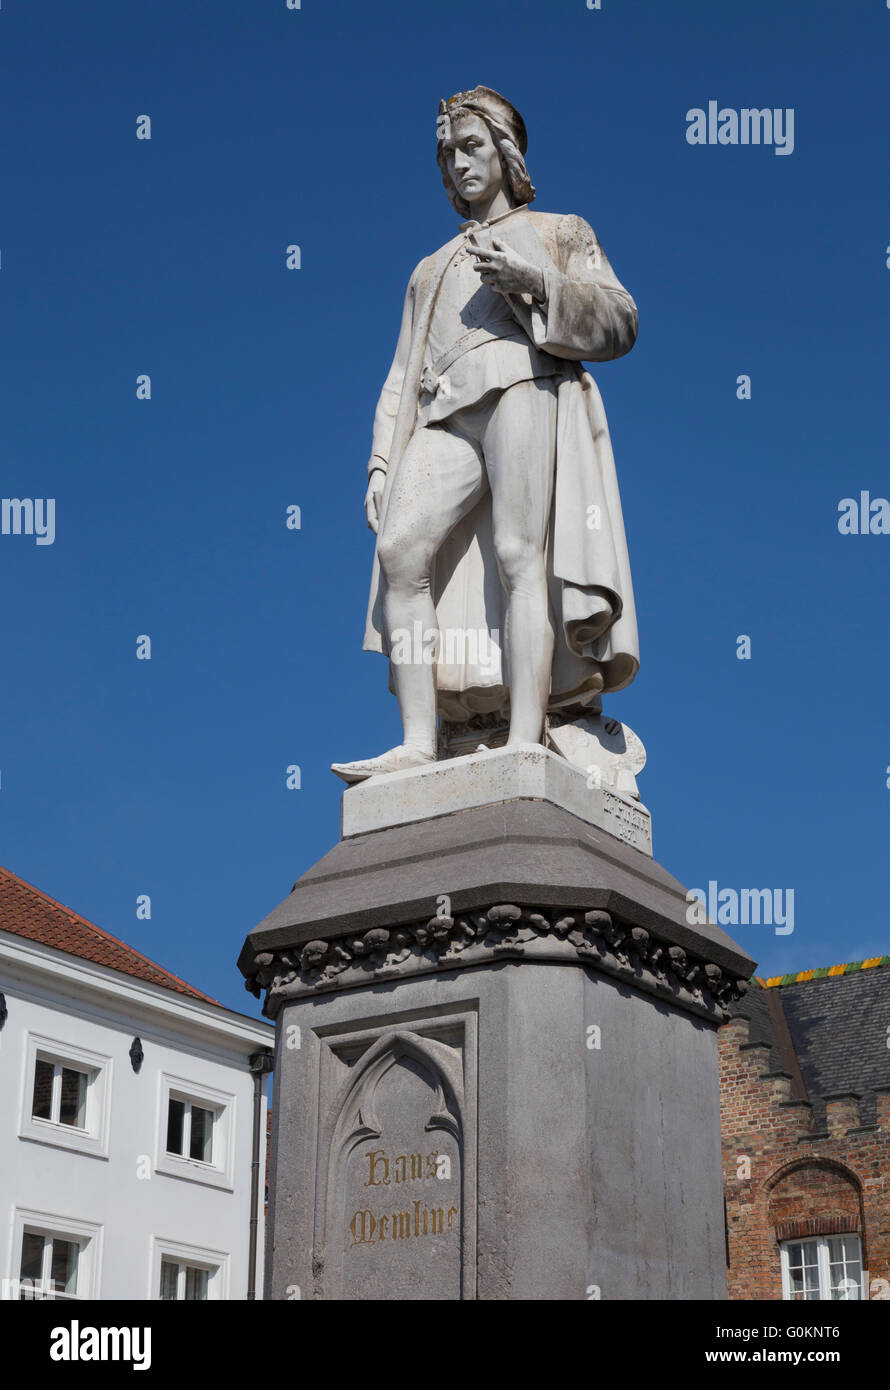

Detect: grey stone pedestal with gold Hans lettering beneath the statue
[239,755,754,1300]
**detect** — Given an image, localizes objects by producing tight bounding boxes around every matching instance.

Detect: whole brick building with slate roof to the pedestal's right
[719,956,890,1300]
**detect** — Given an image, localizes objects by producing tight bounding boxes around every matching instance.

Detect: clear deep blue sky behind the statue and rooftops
[0,0,890,1012]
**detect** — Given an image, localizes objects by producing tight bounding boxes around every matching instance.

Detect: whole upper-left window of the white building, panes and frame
[18,1034,111,1158]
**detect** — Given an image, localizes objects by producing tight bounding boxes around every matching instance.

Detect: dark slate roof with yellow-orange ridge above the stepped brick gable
[731,956,890,1129]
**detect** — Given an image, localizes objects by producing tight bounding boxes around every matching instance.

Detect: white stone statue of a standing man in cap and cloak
[332,86,640,783]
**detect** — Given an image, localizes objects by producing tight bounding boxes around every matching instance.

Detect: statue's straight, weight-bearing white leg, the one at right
[483,377,556,745]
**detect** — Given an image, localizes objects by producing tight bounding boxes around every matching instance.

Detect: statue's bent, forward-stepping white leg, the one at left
[377,425,487,755]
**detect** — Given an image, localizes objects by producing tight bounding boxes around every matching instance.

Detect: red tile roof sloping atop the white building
[0,866,217,1004]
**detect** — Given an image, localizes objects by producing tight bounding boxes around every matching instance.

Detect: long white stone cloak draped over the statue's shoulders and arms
[364,209,640,721]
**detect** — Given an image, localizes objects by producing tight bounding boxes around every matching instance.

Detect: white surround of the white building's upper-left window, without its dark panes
[18,1033,113,1159]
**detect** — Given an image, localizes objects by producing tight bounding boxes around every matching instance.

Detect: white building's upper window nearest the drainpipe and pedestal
[154,1076,235,1191]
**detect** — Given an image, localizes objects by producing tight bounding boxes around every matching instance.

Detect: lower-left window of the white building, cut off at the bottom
[13,1211,102,1301]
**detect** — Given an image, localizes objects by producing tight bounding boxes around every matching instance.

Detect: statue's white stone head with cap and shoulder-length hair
[435,88,534,217]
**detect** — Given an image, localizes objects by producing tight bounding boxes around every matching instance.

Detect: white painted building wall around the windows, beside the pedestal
[0,933,273,1298]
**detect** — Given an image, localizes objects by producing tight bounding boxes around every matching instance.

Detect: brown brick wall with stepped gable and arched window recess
[719,1017,890,1298]
